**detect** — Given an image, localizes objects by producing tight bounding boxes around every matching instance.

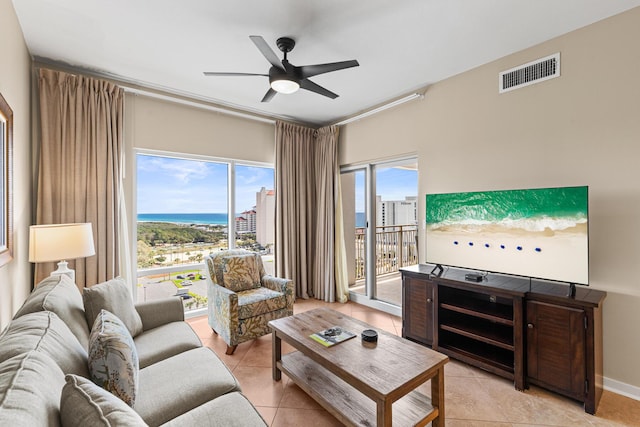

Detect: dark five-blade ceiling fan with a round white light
[204,36,360,102]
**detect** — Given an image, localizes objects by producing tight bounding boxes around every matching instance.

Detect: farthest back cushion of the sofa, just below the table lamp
[14,274,89,348]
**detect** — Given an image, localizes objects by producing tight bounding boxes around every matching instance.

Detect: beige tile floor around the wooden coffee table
[189,300,640,427]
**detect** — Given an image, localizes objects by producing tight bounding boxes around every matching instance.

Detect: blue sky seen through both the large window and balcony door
[137,154,418,213]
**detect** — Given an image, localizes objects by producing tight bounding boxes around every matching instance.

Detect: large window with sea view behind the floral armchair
[136,152,275,311]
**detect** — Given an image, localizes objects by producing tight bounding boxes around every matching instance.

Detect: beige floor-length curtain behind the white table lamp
[35,69,124,288]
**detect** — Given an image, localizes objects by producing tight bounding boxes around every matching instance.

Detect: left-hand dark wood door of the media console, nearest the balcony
[402,275,434,345]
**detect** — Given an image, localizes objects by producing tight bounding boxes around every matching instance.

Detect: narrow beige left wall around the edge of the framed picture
[0,0,31,330]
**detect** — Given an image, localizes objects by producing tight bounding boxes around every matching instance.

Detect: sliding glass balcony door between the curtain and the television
[341,158,418,314]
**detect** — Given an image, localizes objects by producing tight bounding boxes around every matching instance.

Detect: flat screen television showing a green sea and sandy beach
[425,186,589,285]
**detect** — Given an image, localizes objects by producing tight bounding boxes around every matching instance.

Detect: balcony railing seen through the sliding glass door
[355,225,418,280]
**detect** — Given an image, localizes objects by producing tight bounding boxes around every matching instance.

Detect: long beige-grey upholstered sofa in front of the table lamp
[0,275,266,426]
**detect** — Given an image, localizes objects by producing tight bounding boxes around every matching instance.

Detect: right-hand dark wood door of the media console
[527,301,586,400]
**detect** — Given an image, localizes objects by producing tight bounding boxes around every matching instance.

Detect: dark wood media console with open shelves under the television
[401,265,606,414]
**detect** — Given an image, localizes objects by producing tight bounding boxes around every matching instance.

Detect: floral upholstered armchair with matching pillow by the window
[205,249,295,354]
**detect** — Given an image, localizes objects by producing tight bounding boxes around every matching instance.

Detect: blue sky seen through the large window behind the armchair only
[137,154,274,213]
